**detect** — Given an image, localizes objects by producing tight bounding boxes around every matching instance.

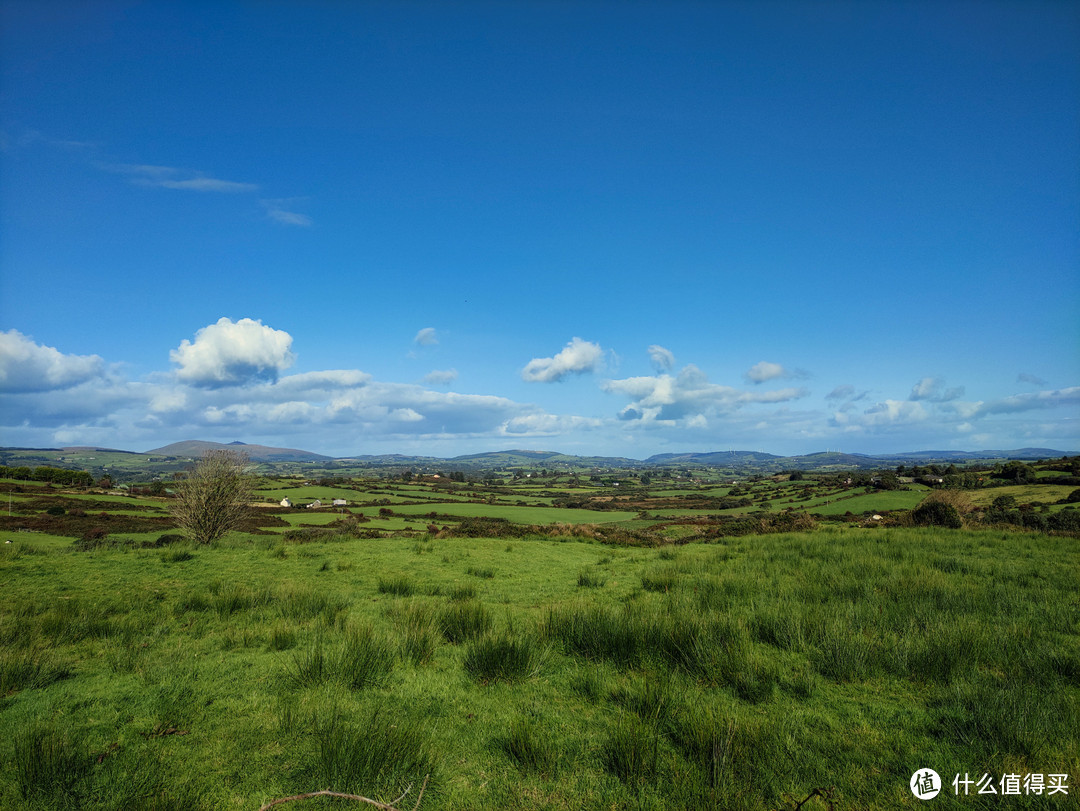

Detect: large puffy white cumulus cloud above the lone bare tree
[168,317,295,388]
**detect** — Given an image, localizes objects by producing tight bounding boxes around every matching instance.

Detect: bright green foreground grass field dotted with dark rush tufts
[0,528,1080,809]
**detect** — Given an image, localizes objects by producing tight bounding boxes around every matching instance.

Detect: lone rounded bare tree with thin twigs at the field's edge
[172,450,252,543]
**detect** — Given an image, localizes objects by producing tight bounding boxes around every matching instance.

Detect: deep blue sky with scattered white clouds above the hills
[0,0,1080,458]
